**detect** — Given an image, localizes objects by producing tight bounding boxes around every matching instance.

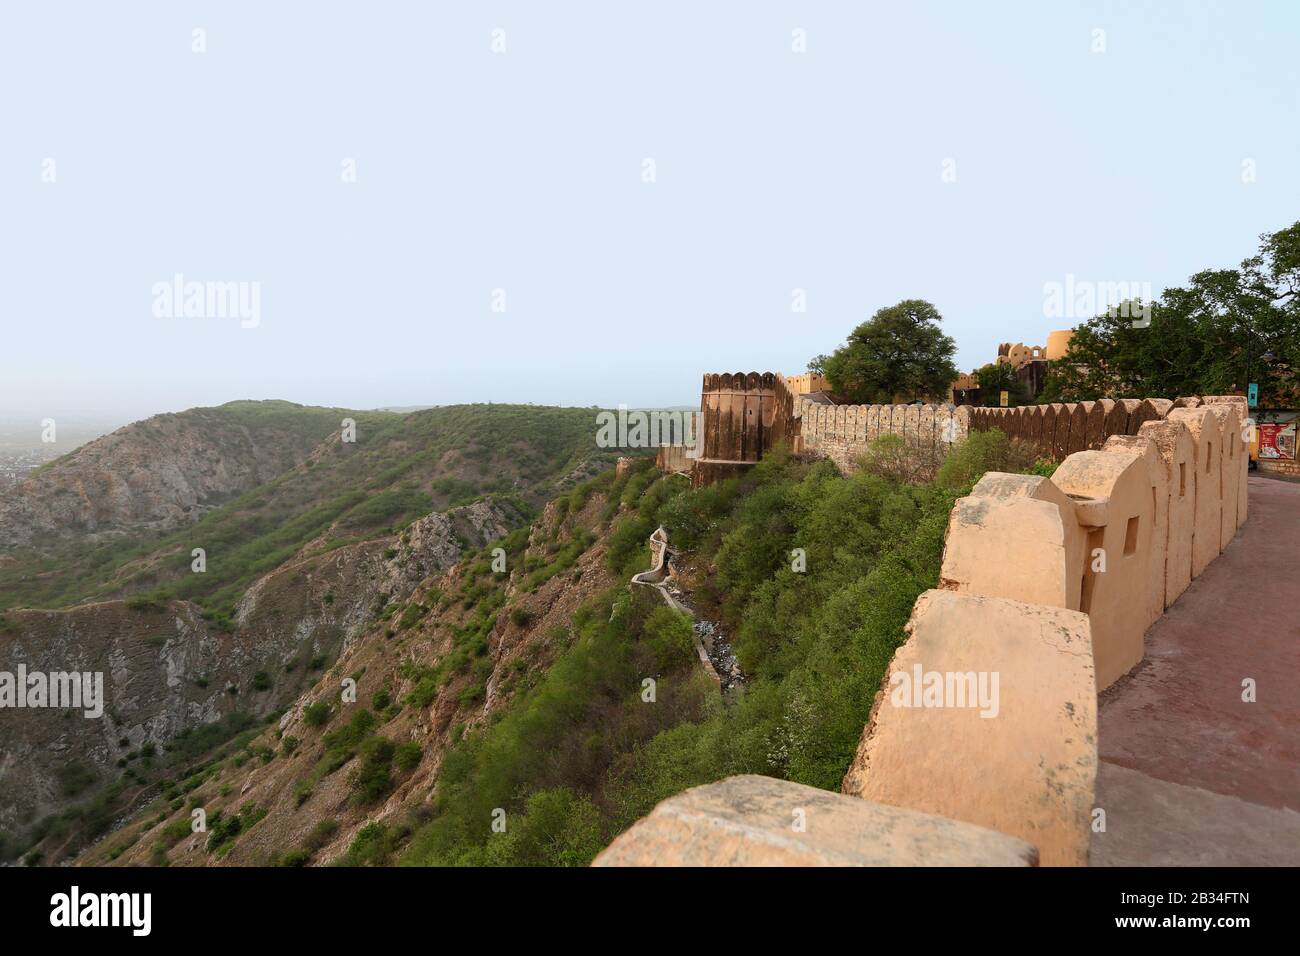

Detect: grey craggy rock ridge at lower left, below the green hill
[0,501,527,862]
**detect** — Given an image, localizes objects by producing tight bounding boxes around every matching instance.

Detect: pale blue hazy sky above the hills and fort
[0,0,1300,420]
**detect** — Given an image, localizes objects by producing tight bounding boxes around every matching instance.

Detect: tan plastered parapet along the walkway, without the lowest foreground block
[844,397,1247,865]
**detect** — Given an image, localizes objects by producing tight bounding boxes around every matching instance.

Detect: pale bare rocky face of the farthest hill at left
[0,402,356,553]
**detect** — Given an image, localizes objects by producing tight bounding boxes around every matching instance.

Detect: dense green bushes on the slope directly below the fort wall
[395,432,1032,865]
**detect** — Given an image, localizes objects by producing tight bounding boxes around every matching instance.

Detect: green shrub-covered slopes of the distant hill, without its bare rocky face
[0,402,618,618]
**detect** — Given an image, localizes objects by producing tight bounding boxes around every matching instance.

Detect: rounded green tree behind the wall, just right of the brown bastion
[809,299,957,403]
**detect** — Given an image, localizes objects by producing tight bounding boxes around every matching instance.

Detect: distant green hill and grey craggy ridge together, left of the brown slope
[0,402,624,862]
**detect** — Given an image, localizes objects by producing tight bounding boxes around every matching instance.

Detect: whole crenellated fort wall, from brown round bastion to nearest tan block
[616,387,1248,866]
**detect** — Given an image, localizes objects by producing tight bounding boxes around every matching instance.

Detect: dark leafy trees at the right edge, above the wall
[1039,222,1300,407]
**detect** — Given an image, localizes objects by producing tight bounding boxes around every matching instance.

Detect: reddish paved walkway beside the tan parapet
[1092,476,1300,866]
